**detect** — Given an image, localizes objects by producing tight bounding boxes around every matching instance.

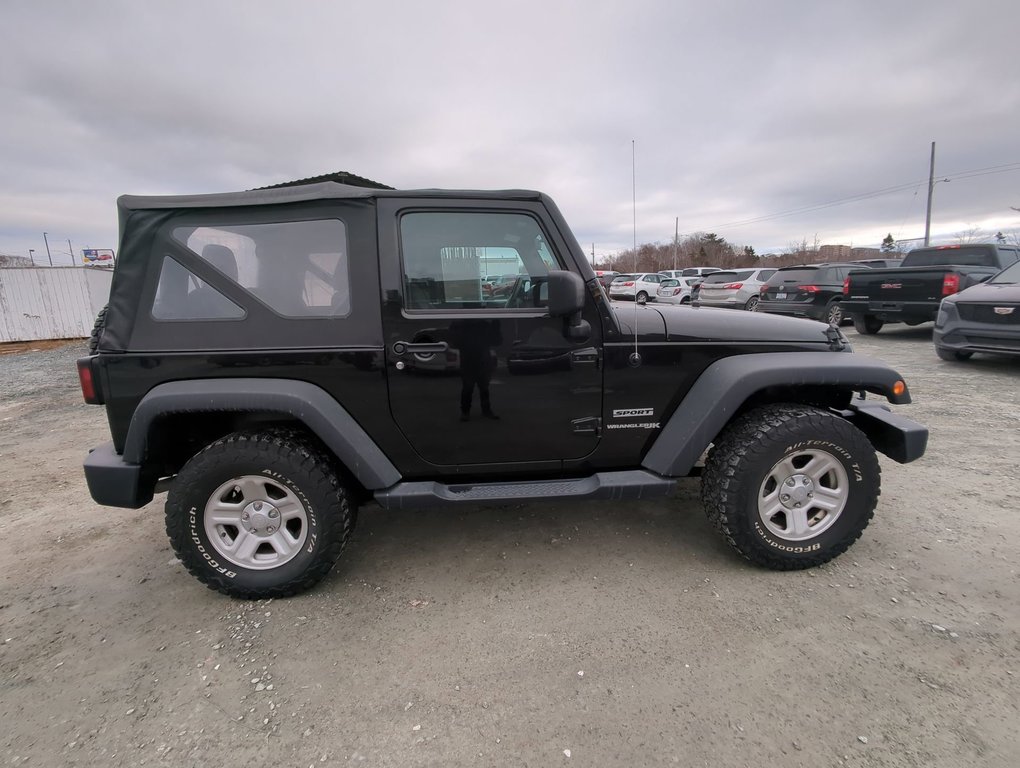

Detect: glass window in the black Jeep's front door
[400,211,562,311]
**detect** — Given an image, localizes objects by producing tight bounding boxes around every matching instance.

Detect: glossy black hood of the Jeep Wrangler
[613,304,828,344]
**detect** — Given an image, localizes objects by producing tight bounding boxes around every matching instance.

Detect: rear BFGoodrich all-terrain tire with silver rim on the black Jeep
[166,430,357,600]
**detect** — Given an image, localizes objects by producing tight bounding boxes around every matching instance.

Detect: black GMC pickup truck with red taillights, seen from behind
[843,243,1020,334]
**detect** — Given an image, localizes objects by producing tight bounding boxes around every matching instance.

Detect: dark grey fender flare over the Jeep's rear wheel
[122,378,401,491]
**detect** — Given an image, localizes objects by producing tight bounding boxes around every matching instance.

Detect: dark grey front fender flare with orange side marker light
[642,352,910,477]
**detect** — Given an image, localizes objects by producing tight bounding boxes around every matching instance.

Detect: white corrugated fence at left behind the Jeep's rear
[0,266,113,343]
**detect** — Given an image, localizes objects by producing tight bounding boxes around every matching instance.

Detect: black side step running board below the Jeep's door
[375,469,676,509]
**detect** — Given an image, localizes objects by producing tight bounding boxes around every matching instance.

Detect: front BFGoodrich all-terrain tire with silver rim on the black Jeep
[702,404,881,570]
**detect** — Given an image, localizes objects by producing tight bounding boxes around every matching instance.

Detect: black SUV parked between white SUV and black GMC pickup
[758,263,868,325]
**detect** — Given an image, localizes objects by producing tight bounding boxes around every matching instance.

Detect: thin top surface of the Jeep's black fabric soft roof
[117,182,543,212]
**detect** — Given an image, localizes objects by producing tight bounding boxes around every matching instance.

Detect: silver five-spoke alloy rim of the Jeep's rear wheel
[205,474,308,570]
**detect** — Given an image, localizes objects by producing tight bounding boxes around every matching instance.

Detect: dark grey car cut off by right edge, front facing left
[932,261,1020,360]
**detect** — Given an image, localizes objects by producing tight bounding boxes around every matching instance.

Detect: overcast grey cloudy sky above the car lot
[0,0,1020,263]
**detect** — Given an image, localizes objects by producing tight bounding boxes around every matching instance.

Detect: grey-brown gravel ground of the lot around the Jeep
[0,326,1020,768]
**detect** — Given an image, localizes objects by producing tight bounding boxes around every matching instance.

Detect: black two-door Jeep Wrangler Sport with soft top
[78,183,927,598]
